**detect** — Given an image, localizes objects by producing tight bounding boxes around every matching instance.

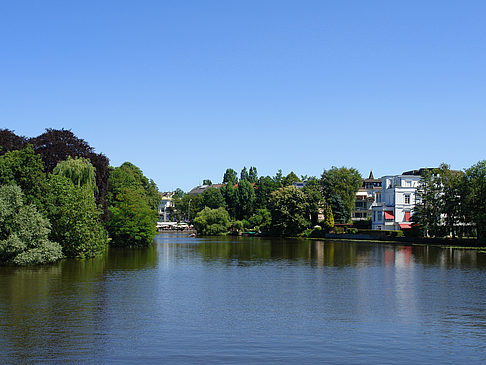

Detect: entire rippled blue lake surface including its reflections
[0,234,486,364]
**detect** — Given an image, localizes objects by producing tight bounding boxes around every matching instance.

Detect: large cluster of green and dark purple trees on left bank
[0,129,160,265]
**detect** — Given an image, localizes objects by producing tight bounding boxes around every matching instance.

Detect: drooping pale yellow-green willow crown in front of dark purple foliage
[52,156,98,194]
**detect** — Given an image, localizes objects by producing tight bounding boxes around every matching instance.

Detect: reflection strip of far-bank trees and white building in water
[192,238,486,268]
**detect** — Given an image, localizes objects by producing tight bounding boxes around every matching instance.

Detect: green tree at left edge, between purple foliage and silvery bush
[0,145,46,206]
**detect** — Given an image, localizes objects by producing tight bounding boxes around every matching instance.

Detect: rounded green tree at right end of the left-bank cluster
[107,188,158,247]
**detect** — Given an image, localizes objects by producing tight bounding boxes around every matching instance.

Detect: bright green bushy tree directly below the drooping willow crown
[43,174,108,258]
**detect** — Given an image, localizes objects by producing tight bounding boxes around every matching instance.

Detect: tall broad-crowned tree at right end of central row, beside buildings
[321,166,362,223]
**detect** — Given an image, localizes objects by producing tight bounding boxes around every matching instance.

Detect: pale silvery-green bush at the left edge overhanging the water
[0,185,63,265]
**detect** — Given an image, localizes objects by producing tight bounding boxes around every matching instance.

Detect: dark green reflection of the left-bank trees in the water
[0,247,157,362]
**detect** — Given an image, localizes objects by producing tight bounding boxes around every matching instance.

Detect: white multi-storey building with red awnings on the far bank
[371,172,420,230]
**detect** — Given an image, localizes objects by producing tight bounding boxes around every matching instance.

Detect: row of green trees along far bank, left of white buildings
[173,167,362,236]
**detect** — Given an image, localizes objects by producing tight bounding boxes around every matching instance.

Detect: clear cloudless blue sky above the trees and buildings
[0,0,486,191]
